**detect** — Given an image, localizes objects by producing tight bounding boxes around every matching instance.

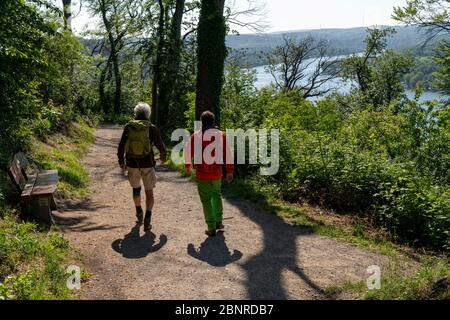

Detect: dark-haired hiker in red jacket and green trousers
[184,111,234,237]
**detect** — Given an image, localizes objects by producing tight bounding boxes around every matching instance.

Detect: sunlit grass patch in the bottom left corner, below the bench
[0,209,79,300]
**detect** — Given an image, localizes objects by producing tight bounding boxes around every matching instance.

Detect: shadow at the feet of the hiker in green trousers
[187,232,242,267]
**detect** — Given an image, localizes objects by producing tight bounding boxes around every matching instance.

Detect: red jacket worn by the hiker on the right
[184,129,234,181]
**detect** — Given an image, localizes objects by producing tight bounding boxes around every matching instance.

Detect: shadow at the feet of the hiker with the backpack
[111,225,167,259]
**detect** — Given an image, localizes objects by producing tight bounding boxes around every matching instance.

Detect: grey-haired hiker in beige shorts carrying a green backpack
[117,102,167,232]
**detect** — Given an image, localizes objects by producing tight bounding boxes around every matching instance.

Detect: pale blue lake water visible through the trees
[253,61,444,102]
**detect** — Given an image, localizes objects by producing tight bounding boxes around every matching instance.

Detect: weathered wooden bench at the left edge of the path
[8,152,58,223]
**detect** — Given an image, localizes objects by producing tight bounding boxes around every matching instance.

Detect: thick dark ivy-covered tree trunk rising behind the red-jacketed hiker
[195,0,227,125]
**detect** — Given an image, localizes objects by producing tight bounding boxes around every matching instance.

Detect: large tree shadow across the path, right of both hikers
[225,188,325,300]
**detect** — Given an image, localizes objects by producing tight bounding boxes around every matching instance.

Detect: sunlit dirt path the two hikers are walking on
[56,127,385,299]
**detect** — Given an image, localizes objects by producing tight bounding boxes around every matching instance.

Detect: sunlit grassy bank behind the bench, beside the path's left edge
[29,123,94,199]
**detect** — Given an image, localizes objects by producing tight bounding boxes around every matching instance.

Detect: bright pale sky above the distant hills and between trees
[54,0,406,33]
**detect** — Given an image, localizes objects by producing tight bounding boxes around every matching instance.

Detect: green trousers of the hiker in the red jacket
[197,179,223,230]
